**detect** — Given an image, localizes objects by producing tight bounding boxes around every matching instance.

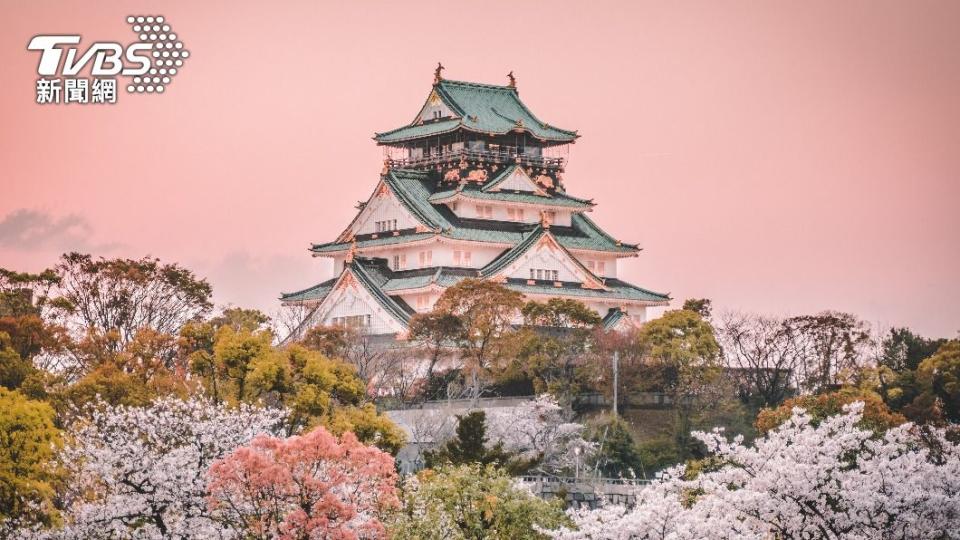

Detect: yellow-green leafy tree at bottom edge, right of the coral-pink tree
[389,464,568,540]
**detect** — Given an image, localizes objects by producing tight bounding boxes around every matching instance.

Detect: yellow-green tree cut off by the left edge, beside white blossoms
[0,388,61,525]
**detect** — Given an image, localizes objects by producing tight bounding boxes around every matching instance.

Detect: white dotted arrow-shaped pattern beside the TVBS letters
[127,15,190,94]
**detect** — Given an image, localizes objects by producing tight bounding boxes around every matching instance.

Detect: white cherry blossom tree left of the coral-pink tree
[48,398,284,539]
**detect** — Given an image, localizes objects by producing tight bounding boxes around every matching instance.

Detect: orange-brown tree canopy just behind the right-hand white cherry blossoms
[755,388,907,435]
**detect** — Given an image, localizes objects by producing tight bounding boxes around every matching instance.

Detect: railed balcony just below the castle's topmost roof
[387,146,564,173]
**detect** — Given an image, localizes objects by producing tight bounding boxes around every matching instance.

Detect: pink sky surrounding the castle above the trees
[0,0,960,336]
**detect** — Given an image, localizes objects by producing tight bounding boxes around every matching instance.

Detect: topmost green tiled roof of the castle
[374,80,577,144]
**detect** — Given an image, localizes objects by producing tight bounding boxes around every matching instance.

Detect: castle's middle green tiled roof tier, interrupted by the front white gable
[310,169,637,253]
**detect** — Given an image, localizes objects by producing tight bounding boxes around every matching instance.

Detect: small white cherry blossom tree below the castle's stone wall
[487,394,595,474]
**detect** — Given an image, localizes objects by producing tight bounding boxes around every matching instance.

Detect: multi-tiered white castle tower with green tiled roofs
[281,70,670,336]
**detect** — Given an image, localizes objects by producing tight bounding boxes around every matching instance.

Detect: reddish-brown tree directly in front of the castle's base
[433,279,523,399]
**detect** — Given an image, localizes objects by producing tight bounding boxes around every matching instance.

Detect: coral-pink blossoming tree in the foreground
[209,427,399,540]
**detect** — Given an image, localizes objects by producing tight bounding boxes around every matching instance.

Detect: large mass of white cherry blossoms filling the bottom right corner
[551,402,960,540]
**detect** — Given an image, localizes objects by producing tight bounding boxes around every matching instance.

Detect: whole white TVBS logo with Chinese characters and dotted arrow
[27,16,190,104]
